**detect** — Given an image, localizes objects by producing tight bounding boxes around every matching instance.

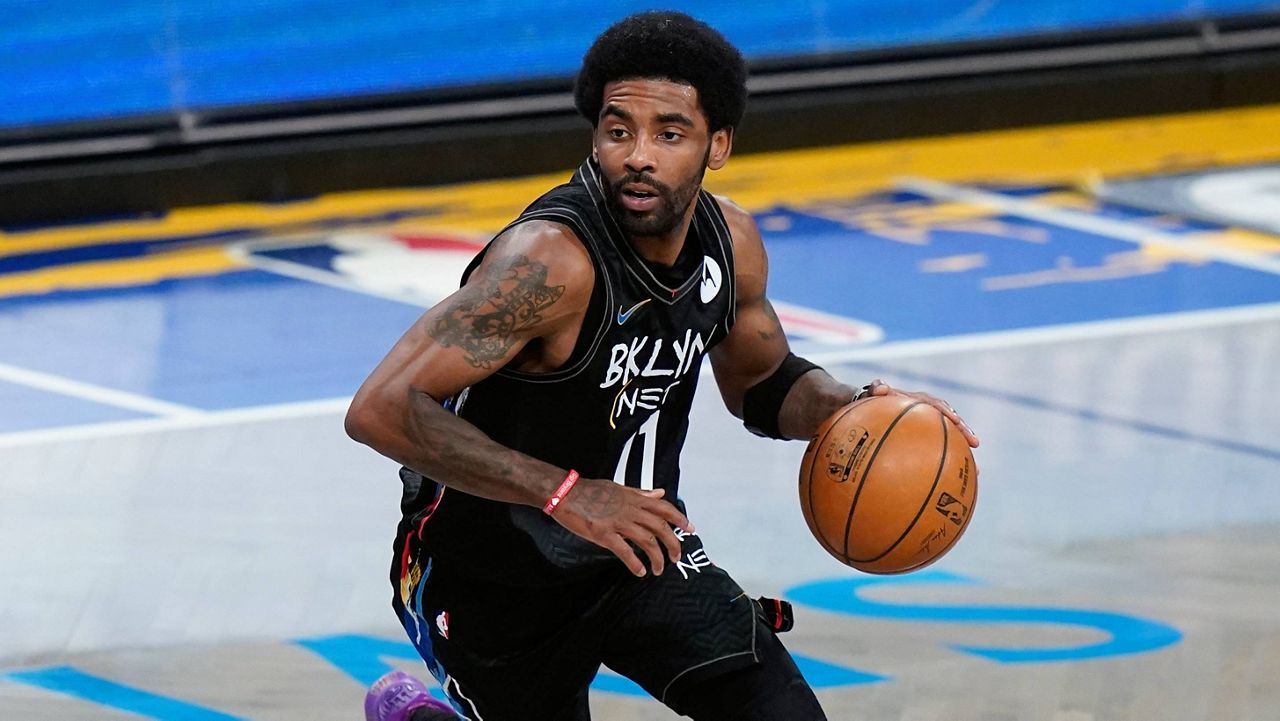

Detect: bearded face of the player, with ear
[594,79,732,238]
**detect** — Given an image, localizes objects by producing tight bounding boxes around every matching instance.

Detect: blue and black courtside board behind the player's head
[0,0,1280,222]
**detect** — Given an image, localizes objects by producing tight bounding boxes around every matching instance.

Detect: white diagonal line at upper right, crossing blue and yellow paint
[896,178,1280,275]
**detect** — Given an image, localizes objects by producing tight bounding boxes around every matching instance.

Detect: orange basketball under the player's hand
[800,394,978,574]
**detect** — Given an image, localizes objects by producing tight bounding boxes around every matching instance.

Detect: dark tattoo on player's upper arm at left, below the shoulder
[428,255,564,368]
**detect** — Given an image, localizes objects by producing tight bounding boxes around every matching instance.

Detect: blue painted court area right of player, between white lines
[756,192,1280,342]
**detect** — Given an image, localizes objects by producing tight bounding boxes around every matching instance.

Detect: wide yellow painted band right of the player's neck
[708,105,1280,209]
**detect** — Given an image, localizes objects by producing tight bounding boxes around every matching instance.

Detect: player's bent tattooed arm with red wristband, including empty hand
[346,222,691,575]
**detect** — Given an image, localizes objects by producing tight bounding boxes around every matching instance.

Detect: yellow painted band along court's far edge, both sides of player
[0,105,1280,257]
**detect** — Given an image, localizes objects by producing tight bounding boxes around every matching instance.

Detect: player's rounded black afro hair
[573,12,746,132]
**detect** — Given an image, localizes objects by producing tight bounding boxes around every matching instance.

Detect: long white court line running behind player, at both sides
[0,302,1280,448]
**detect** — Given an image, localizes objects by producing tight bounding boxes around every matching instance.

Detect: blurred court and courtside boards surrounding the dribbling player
[0,0,1280,721]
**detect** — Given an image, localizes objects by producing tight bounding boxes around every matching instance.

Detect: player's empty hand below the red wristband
[552,478,694,576]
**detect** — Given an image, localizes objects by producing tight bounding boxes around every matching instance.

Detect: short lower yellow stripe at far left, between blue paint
[0,246,247,297]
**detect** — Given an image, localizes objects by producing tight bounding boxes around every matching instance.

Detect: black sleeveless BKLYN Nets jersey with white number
[401,160,735,585]
